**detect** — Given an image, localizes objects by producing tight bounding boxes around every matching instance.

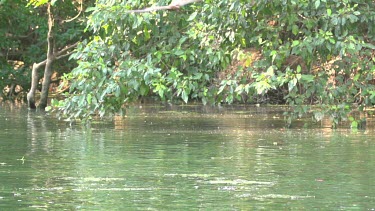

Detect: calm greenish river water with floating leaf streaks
[0,102,375,210]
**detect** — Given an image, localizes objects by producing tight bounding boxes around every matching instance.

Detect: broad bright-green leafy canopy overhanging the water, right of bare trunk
[54,0,375,128]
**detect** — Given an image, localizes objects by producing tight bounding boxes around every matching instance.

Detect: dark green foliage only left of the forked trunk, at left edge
[0,0,39,98]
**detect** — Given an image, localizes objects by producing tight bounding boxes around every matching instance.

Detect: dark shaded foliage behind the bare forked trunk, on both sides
[0,0,89,98]
